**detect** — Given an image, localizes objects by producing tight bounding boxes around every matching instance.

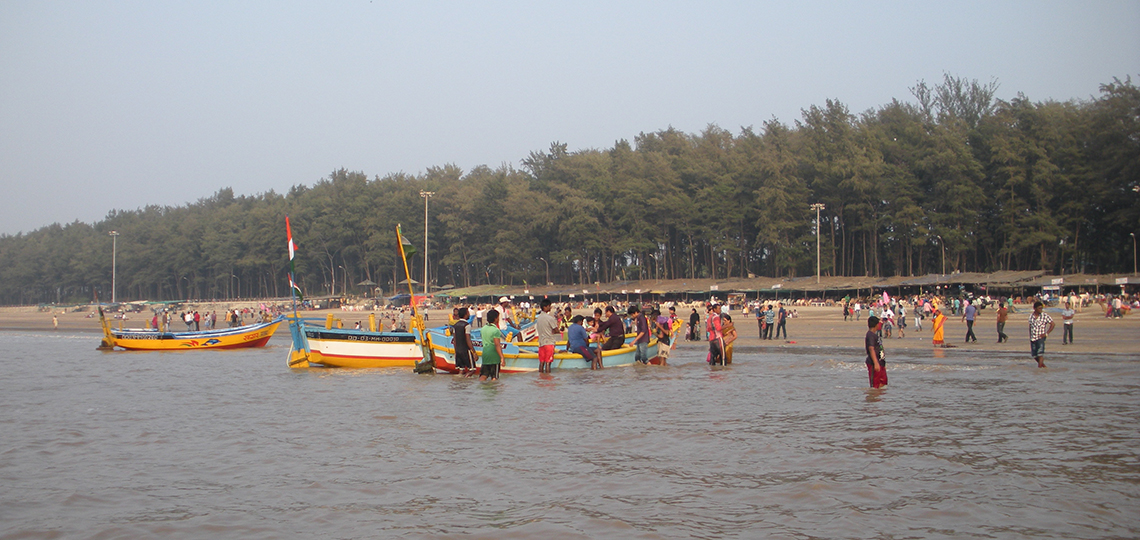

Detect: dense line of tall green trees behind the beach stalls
[0,76,1140,304]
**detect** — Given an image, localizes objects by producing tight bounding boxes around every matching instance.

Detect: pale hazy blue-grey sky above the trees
[0,0,1140,235]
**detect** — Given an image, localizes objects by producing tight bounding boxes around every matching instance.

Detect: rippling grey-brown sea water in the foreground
[0,333,1140,539]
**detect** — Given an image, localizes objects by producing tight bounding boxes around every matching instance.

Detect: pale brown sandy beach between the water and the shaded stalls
[0,303,1140,357]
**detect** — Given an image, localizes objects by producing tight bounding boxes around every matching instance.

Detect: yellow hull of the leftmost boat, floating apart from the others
[111,318,284,351]
